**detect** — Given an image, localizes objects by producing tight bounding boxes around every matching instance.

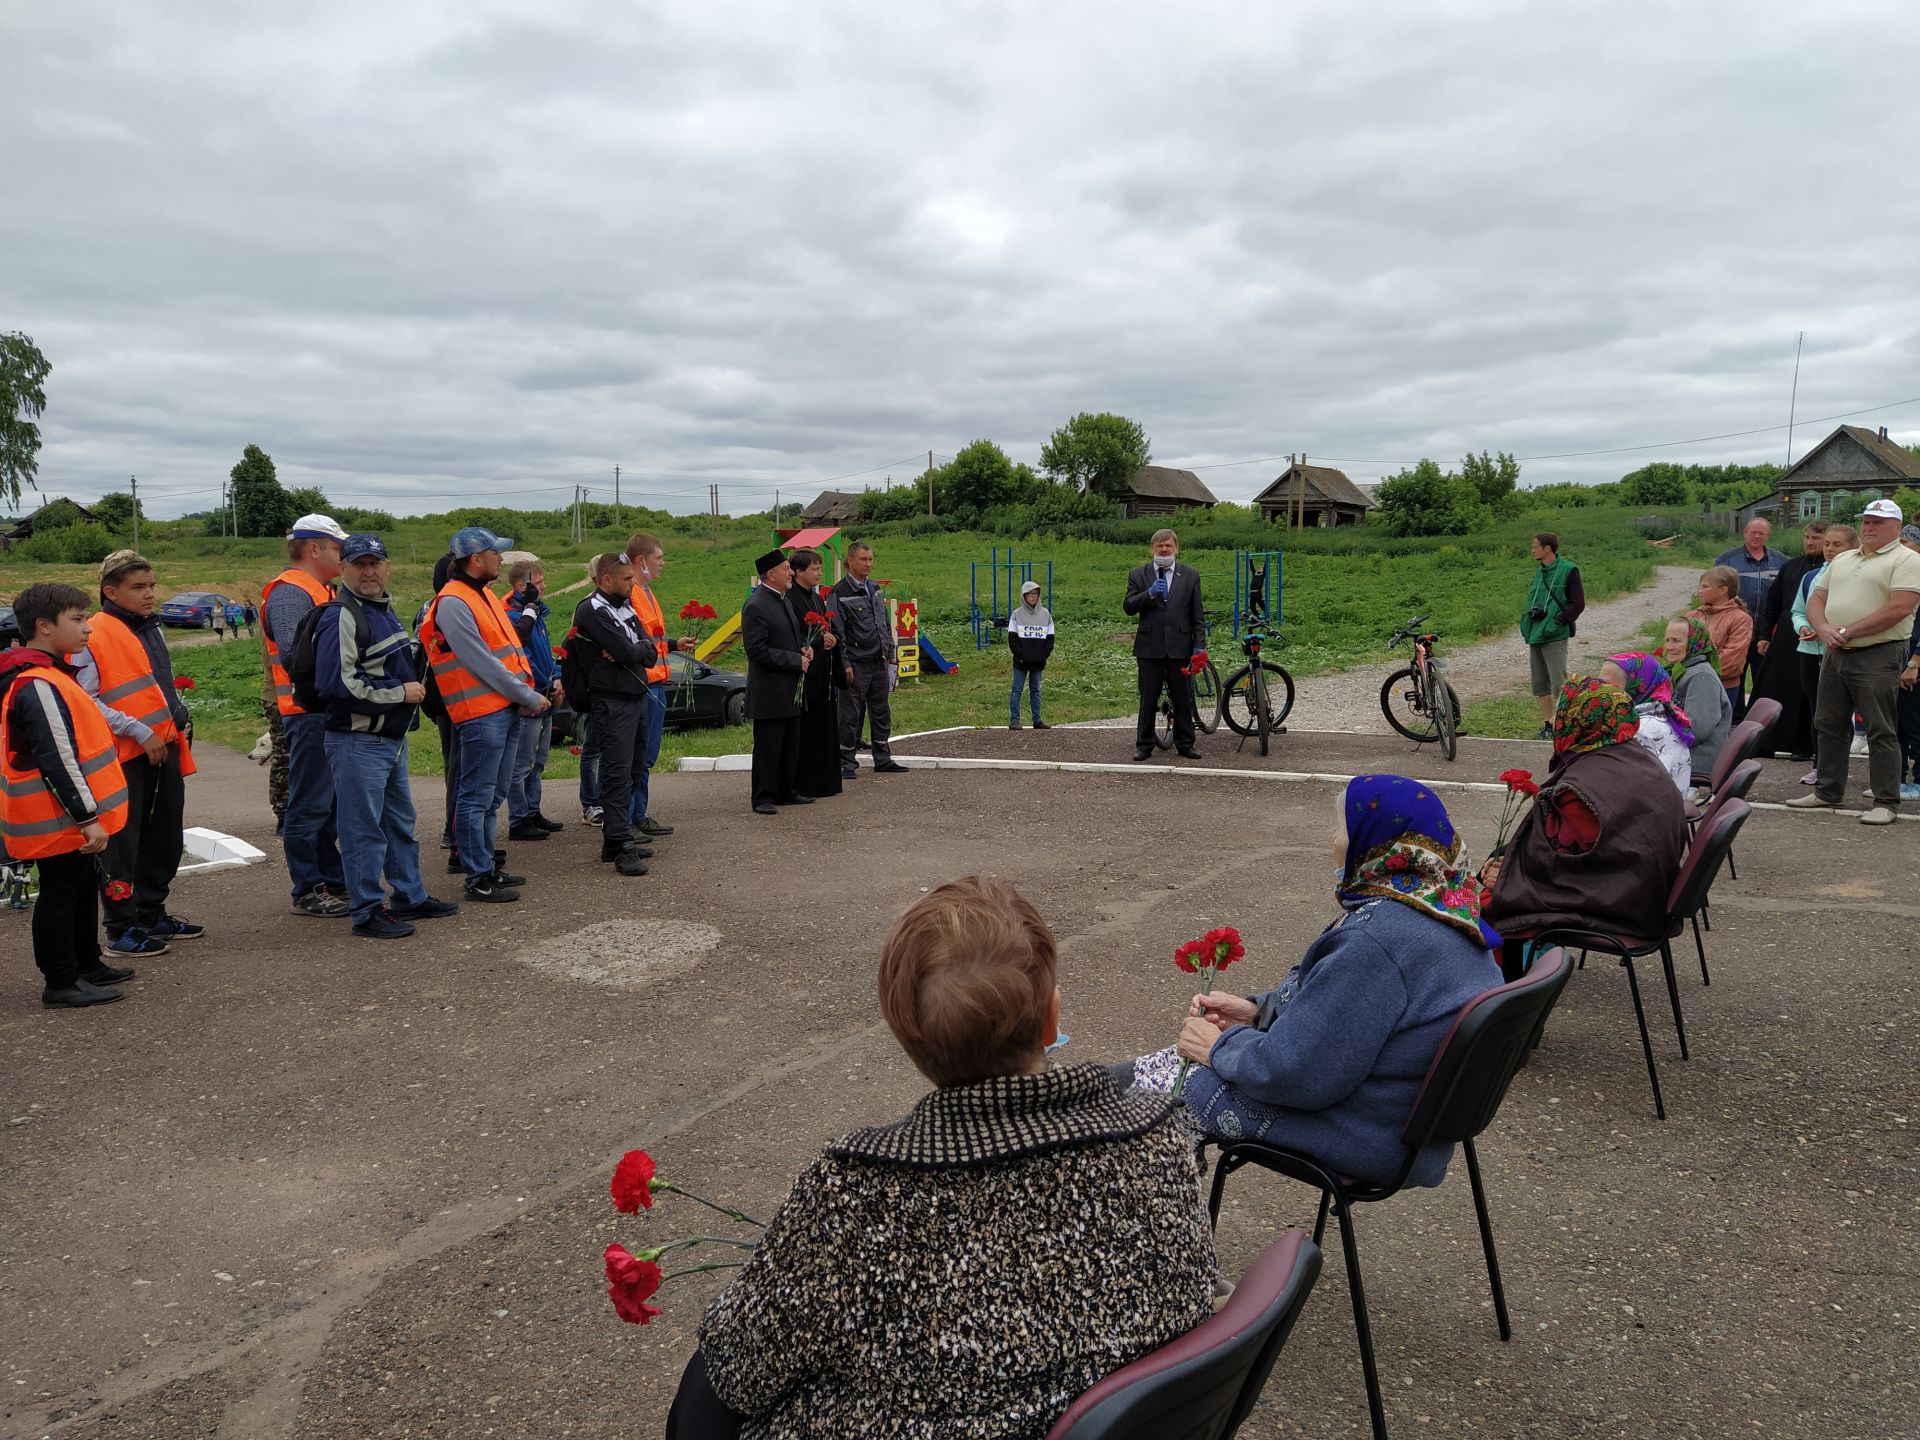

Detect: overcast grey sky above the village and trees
[0,0,1920,515]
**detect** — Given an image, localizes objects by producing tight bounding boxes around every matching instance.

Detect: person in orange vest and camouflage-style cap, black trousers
[73,549,205,956]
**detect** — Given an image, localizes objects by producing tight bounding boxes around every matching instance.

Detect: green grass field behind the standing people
[0,509,1726,778]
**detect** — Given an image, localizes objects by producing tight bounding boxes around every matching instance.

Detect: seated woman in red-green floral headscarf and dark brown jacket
[1486,678,1688,975]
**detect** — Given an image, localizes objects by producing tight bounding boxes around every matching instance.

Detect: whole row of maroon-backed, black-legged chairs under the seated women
[1048,714,1778,1440]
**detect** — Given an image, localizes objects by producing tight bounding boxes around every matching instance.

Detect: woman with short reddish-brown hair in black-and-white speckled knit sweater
[666,876,1215,1440]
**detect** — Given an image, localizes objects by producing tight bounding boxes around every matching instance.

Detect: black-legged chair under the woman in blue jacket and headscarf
[1208,950,1572,1440]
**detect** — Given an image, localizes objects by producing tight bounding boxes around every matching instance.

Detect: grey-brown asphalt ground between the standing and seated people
[0,732,1920,1440]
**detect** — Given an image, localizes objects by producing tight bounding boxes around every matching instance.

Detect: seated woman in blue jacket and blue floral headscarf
[1116,776,1501,1185]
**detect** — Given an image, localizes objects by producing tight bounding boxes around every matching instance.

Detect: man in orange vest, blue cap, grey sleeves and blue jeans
[420,526,551,902]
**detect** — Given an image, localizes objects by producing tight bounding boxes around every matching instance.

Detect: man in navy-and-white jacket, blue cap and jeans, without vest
[313,536,459,941]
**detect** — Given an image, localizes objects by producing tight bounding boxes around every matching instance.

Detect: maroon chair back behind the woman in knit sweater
[1046,1231,1321,1440]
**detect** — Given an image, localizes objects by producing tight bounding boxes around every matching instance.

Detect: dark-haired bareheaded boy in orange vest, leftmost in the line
[0,582,134,1010]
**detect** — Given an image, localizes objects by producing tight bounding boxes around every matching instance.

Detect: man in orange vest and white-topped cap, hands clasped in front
[259,515,351,920]
